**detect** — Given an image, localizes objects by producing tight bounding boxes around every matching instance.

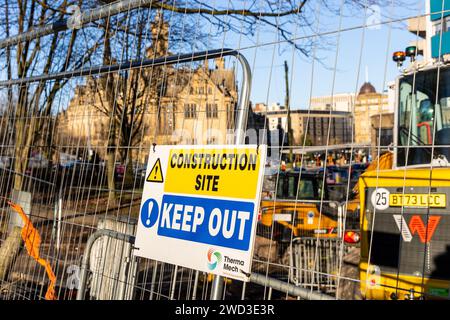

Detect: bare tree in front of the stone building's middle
[89,10,163,203]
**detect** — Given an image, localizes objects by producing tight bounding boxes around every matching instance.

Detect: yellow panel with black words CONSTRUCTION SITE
[164,148,261,199]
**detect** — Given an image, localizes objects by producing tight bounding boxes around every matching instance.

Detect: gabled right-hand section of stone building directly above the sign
[147,59,237,144]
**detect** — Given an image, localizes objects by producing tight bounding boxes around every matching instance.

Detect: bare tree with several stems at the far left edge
[3,0,102,190]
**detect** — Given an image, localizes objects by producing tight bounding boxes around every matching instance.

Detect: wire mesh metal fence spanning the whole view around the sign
[0,0,450,300]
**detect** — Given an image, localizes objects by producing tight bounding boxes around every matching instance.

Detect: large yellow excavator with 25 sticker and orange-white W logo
[358,49,450,300]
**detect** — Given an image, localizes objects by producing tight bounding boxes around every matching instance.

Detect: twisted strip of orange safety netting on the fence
[8,202,57,300]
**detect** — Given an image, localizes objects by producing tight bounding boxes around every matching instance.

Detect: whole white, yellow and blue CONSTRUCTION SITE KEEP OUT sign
[134,145,266,281]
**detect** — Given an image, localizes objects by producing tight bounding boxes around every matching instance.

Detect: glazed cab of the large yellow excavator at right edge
[396,67,450,167]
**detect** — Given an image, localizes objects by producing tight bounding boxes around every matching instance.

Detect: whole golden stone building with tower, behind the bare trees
[58,18,237,163]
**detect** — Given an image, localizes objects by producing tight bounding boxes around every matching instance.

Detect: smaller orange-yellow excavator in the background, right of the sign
[259,170,359,243]
